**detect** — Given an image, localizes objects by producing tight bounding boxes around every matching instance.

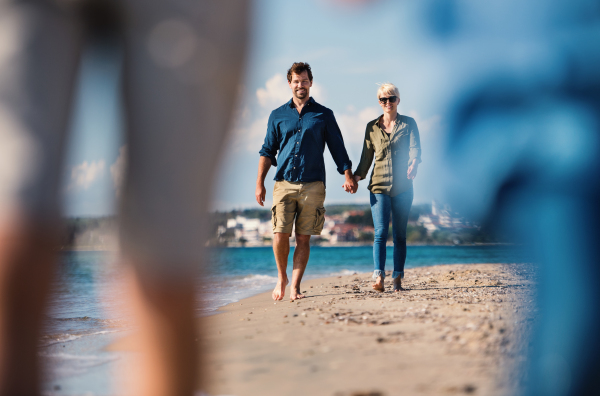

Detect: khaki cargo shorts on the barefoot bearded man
[271,180,325,235]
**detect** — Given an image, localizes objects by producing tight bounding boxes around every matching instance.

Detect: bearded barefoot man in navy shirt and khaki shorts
[256,62,358,300]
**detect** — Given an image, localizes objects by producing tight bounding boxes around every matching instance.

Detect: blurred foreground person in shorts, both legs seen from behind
[0,0,249,396]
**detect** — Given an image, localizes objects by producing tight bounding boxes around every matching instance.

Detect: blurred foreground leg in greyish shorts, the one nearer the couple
[120,0,249,396]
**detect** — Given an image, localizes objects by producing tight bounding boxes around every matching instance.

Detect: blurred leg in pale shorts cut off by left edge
[0,0,81,396]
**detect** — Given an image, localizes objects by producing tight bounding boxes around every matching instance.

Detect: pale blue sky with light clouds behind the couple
[64,0,451,216]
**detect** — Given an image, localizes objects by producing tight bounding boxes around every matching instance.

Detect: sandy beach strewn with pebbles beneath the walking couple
[198,263,536,396]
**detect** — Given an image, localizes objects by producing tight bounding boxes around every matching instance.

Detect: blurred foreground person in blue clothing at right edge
[423,0,600,396]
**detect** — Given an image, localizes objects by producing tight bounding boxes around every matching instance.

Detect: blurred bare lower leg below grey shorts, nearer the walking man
[124,266,199,396]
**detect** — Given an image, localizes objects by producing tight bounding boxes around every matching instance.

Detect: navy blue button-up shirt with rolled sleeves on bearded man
[260,97,352,183]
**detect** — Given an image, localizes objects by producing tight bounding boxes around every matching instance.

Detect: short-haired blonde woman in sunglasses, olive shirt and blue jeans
[354,83,421,292]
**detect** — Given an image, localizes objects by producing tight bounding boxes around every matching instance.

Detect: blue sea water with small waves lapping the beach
[39,245,531,395]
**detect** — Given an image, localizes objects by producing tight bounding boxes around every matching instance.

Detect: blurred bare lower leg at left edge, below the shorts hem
[0,221,56,396]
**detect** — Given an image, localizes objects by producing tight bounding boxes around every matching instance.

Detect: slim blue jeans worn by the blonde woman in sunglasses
[371,188,413,279]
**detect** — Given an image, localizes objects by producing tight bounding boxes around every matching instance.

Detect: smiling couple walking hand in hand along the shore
[256,62,421,300]
